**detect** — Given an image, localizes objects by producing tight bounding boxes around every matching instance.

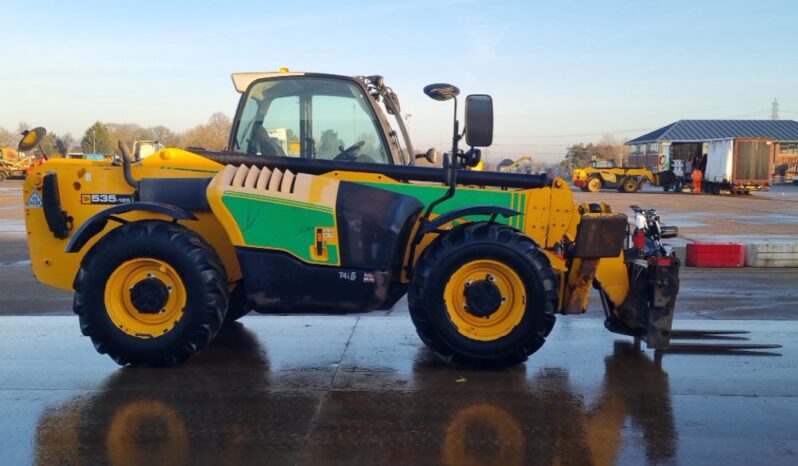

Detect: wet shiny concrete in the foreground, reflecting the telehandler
[0,316,798,466]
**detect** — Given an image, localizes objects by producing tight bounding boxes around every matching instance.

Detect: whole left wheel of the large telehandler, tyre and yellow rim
[74,221,228,366]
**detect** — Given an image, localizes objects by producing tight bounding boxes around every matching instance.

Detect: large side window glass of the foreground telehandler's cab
[233,77,391,164]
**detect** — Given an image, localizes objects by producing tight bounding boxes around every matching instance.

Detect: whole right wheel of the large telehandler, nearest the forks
[408,223,557,367]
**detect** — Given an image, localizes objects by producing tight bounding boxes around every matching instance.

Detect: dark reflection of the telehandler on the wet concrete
[34,325,678,466]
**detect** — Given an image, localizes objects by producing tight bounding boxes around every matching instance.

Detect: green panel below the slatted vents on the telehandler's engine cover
[222,193,340,265]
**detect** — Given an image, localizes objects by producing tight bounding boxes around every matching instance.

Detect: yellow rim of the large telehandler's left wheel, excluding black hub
[105,258,186,338]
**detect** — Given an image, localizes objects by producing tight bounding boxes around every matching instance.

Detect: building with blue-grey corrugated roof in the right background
[626,120,798,175]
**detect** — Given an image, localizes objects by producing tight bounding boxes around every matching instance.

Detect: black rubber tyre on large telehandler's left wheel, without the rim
[74,220,228,366]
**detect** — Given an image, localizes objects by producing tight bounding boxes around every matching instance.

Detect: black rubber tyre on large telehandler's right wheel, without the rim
[408,222,558,367]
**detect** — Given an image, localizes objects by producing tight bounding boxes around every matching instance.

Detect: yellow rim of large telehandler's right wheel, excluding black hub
[443,259,526,341]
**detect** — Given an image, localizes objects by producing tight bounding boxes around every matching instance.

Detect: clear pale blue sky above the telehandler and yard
[0,0,798,161]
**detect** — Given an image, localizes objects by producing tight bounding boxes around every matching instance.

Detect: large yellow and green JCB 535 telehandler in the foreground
[20,70,679,367]
